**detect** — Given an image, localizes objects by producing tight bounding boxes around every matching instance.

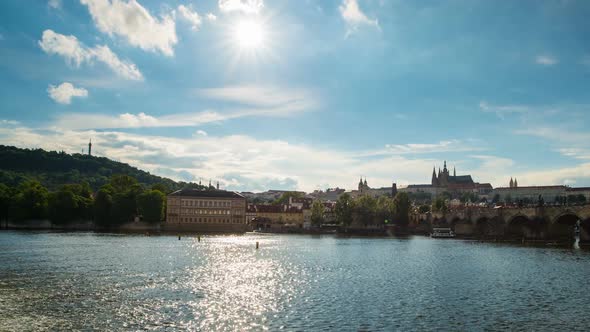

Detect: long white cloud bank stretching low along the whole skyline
[0,124,590,191]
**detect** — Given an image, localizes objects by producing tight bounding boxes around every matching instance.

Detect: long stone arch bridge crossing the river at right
[414,205,590,242]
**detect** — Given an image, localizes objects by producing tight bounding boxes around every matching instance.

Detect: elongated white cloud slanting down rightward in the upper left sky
[39,30,143,81]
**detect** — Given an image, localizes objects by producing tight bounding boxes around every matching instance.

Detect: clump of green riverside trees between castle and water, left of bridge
[334,193,411,229]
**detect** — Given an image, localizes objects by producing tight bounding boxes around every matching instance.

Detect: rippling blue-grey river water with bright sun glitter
[0,231,590,331]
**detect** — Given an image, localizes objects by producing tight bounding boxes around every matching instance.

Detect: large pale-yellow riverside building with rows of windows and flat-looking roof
[164,189,246,232]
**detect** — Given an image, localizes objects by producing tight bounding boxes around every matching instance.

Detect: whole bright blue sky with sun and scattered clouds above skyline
[0,0,590,191]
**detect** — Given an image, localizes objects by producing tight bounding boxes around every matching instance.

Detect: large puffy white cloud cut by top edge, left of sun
[80,0,178,56]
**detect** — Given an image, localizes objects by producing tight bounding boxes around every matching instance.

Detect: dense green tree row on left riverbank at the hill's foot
[0,175,166,227]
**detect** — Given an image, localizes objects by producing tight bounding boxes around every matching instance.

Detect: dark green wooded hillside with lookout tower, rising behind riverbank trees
[0,145,195,191]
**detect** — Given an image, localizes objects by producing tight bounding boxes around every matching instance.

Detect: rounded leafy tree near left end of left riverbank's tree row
[15,180,49,219]
